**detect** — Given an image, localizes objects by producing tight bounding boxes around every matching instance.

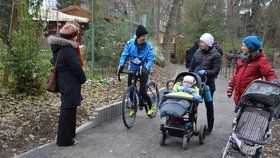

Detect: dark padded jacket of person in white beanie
[189,47,221,91]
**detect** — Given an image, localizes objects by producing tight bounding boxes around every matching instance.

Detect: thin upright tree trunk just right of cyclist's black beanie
[154,0,160,42]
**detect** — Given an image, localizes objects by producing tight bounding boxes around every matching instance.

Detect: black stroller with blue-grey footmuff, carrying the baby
[160,72,206,150]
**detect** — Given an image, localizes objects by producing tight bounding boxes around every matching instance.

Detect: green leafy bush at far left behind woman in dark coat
[6,0,45,95]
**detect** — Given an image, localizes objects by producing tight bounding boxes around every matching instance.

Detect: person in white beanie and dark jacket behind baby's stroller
[189,33,221,134]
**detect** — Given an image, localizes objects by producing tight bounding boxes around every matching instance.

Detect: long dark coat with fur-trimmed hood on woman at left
[48,36,86,108]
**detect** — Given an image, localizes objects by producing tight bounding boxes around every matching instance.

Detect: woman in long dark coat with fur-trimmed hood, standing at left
[48,23,86,146]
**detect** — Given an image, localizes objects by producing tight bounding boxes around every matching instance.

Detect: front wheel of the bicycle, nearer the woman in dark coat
[122,86,138,129]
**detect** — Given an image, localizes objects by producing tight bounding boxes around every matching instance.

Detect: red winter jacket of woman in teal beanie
[229,49,277,105]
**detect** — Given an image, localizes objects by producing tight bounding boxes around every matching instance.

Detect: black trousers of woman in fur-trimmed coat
[56,107,77,146]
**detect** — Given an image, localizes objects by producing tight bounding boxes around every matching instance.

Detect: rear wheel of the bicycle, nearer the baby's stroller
[145,82,159,118]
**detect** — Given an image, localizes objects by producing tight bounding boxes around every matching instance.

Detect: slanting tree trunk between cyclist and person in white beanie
[163,0,182,63]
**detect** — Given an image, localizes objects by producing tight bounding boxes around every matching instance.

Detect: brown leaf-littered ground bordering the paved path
[0,66,280,158]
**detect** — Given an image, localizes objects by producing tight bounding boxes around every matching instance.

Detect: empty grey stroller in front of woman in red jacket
[222,80,280,158]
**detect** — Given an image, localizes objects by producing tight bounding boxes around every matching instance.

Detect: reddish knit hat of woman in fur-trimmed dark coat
[59,23,79,39]
